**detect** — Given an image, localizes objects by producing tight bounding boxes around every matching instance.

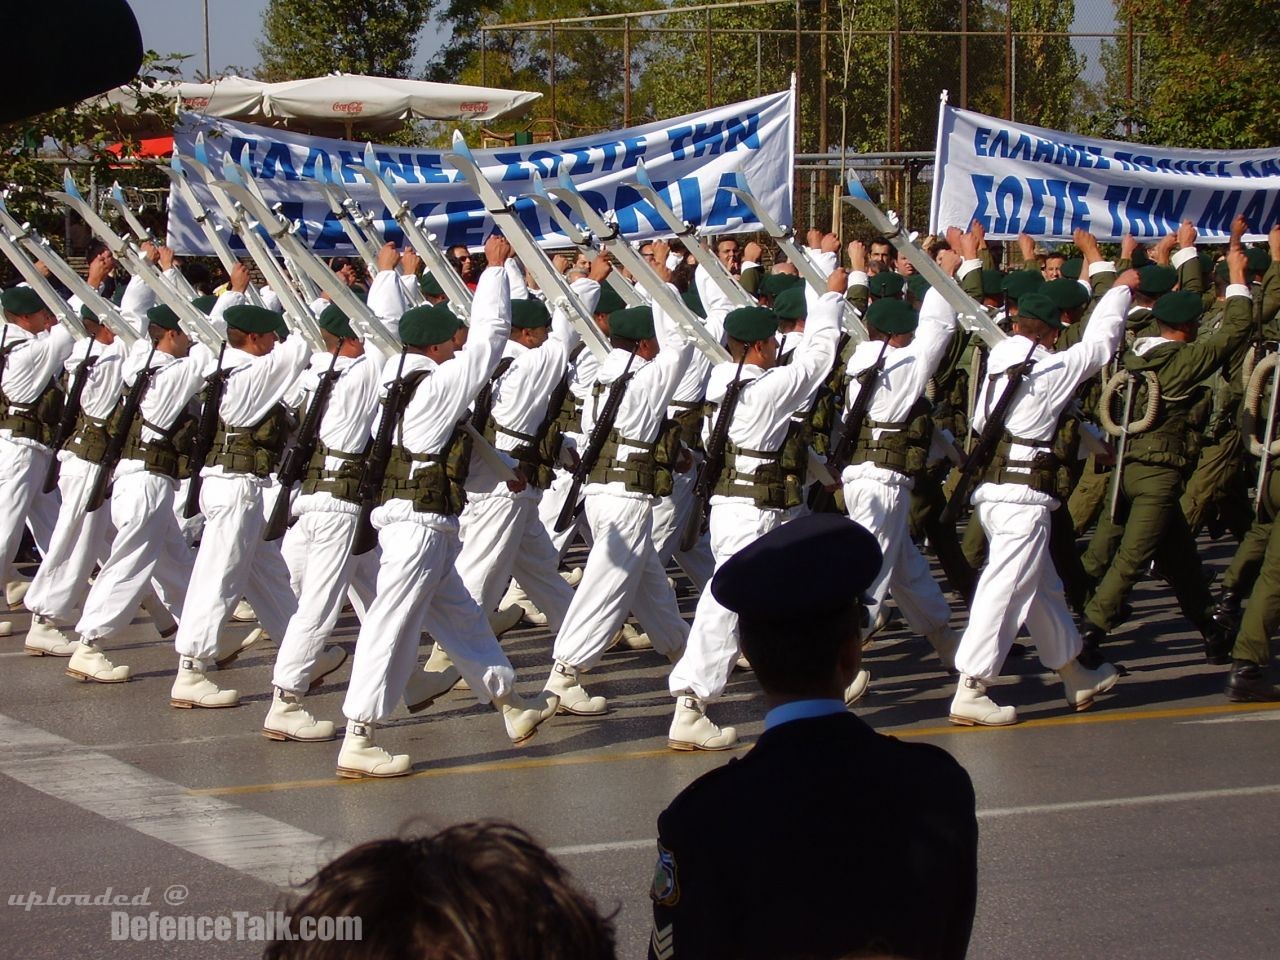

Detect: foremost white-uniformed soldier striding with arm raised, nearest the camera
[338,236,556,777]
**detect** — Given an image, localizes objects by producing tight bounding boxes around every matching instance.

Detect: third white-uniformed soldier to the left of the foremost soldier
[67,305,218,684]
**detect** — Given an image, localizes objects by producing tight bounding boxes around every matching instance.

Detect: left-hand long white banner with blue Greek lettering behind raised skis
[169,91,795,256]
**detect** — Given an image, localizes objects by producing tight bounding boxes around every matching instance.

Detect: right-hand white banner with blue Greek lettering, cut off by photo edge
[929,101,1280,241]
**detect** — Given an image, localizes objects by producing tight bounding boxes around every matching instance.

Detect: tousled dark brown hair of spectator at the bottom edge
[264,822,614,960]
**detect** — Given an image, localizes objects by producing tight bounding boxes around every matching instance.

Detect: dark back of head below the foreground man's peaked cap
[737,603,861,698]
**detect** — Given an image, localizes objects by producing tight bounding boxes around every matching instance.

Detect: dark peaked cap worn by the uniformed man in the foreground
[712,513,882,623]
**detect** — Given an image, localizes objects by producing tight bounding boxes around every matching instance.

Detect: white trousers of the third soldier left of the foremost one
[76,470,196,641]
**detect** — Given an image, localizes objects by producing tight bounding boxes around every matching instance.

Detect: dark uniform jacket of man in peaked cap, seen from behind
[649,713,978,960]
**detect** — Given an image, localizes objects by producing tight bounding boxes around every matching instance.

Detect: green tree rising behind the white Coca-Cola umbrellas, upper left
[256,0,434,82]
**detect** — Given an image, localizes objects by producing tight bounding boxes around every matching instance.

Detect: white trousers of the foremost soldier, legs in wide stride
[342,512,516,723]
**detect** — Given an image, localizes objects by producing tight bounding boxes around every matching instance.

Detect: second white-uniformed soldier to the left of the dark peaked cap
[547,277,694,716]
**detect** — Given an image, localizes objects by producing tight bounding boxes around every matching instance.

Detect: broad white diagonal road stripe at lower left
[0,714,333,887]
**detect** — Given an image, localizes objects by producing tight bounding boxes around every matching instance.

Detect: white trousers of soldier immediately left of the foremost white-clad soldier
[271,509,360,695]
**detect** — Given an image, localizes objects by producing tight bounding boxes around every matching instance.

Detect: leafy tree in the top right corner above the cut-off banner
[1089,0,1280,150]
